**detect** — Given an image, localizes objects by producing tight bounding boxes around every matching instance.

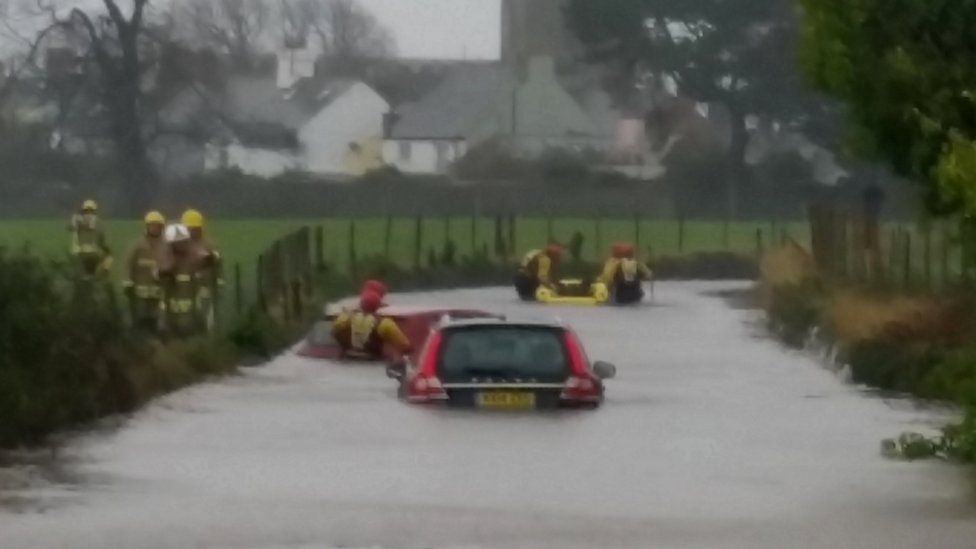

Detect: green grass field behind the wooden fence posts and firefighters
[0,217,807,318]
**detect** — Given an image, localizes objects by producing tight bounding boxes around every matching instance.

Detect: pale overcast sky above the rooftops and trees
[0,0,501,59]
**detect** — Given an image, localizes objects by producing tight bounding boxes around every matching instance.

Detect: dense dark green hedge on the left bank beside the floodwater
[0,250,236,447]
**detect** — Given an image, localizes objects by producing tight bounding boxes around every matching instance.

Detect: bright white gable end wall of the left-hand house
[298,83,390,175]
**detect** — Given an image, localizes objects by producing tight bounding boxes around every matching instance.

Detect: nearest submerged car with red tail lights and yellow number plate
[387,318,616,410]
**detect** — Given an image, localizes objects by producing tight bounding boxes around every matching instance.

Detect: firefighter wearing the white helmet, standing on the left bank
[159,224,205,337]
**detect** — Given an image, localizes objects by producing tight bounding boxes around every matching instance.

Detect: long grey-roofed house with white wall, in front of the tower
[383,56,609,173]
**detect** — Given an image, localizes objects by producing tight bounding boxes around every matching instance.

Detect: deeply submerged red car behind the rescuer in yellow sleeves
[298,306,496,360]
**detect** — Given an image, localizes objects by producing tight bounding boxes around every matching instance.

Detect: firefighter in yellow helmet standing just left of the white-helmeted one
[122,211,166,332]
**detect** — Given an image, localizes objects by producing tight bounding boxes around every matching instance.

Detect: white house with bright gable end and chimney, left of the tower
[166,63,390,177]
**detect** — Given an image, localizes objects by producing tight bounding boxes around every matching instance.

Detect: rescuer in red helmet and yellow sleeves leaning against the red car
[332,291,411,359]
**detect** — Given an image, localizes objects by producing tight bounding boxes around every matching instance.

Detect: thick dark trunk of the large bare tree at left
[70,0,156,211]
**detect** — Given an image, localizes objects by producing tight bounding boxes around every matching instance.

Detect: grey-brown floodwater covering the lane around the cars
[0,283,976,549]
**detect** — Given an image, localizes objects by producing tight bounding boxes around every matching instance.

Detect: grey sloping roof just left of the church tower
[390,63,515,139]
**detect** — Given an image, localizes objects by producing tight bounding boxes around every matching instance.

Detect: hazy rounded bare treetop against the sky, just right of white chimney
[282,0,395,63]
